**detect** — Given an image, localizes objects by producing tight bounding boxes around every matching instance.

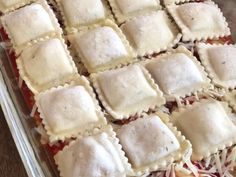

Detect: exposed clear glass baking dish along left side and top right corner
[0,0,236,177]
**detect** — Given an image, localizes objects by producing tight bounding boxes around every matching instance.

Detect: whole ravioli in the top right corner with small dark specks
[168,1,230,41]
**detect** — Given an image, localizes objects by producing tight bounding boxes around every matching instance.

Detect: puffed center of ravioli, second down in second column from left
[76,26,128,69]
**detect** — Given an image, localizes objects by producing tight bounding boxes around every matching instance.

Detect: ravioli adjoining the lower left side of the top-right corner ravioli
[121,10,181,56]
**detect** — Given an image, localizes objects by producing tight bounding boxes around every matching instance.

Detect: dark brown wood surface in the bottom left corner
[0,107,27,177]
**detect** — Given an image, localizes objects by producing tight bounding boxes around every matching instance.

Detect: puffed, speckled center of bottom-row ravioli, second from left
[117,115,180,168]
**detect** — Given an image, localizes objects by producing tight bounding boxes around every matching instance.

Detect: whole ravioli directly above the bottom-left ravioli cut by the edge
[35,76,106,142]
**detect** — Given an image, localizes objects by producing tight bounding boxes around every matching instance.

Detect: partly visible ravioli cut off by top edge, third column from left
[108,0,161,23]
